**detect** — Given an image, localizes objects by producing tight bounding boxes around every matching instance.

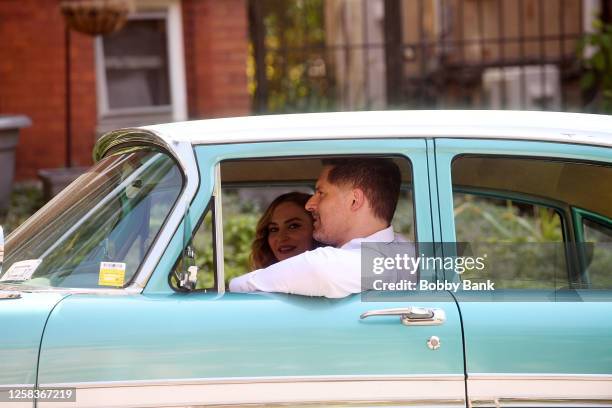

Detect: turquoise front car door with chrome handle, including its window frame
[39,139,465,406]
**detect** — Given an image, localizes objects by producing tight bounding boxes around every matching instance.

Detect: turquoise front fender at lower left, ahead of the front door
[0,289,69,386]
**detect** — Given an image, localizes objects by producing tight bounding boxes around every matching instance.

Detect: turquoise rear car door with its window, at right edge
[435,139,612,406]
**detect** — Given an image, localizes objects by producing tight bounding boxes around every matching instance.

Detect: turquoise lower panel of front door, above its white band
[39,293,464,399]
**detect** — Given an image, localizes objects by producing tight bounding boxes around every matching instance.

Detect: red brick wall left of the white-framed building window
[0,0,96,179]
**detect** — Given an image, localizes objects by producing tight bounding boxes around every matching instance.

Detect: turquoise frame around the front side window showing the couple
[142,137,433,296]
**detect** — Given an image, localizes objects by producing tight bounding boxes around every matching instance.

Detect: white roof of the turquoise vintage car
[141,110,612,147]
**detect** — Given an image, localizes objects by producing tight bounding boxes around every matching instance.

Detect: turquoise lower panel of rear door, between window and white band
[458,290,612,374]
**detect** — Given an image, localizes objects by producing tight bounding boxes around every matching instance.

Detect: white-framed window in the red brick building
[96,0,187,133]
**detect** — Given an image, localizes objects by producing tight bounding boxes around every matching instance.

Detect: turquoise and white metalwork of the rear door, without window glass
[435,139,612,401]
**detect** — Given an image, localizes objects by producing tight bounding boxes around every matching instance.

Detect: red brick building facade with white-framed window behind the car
[0,0,251,180]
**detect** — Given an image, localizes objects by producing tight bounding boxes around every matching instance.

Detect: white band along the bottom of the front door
[39,374,466,408]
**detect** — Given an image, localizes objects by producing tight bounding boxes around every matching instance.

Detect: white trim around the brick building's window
[95,0,187,121]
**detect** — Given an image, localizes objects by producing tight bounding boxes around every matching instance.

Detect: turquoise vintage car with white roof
[0,111,612,407]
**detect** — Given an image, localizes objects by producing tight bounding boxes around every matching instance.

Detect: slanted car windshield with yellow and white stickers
[0,149,183,288]
